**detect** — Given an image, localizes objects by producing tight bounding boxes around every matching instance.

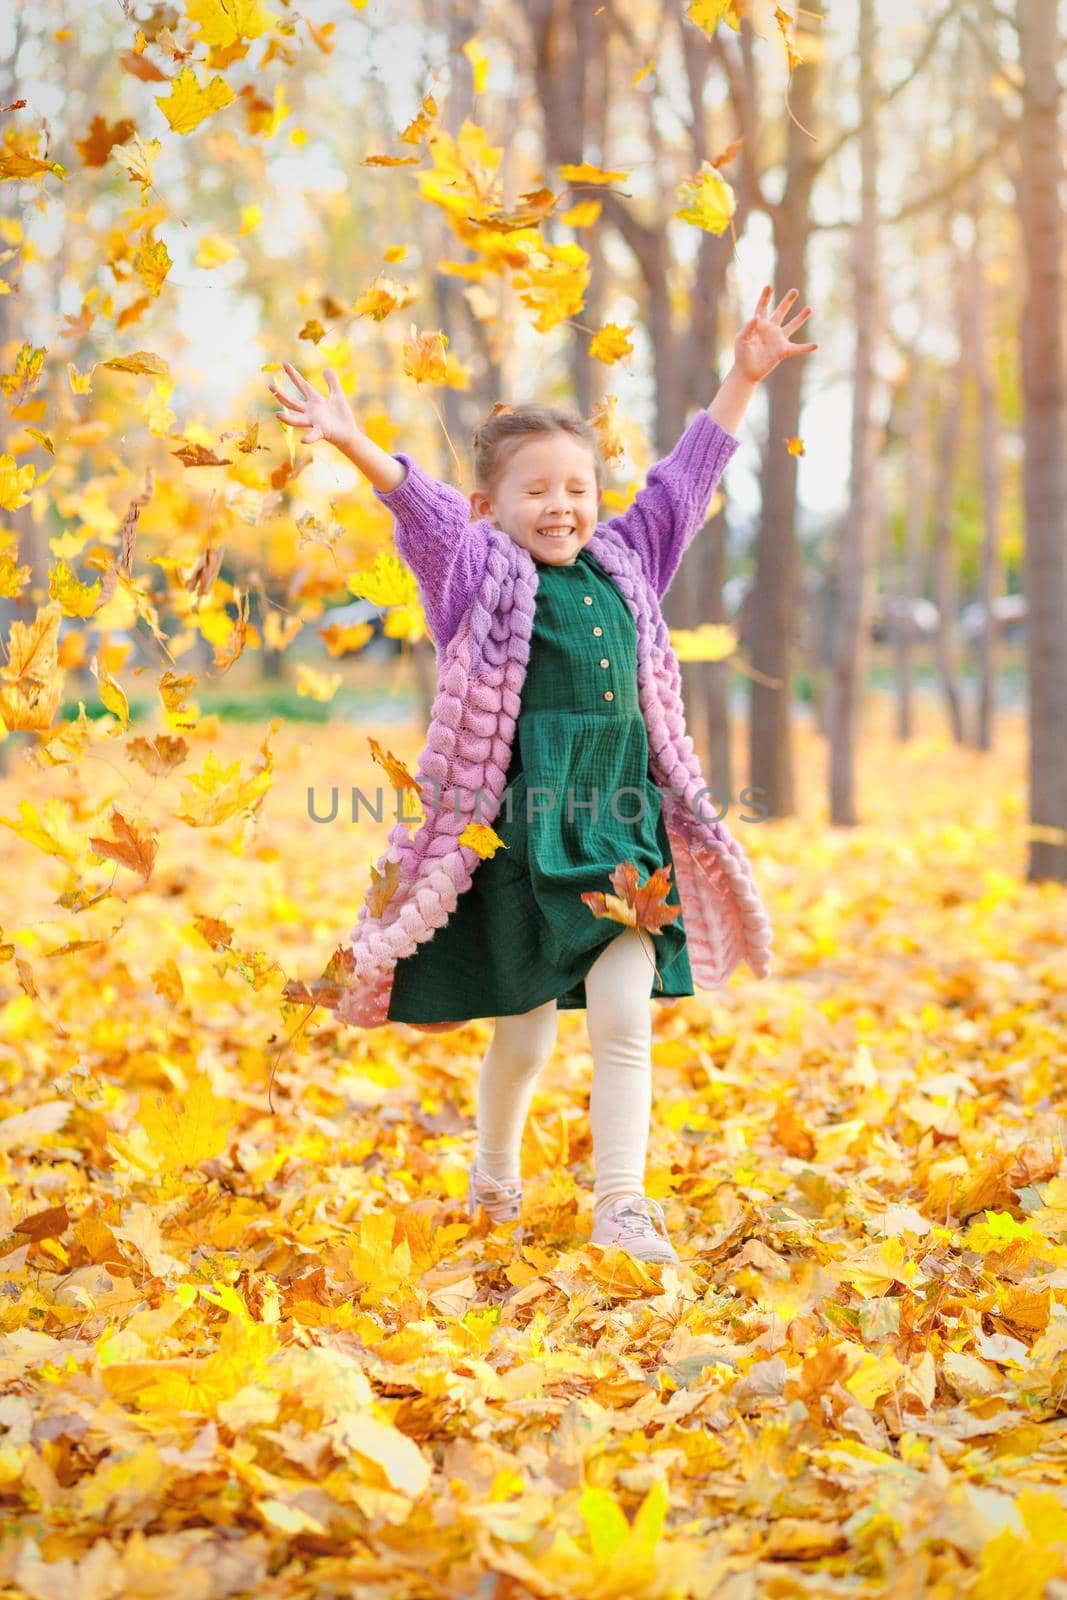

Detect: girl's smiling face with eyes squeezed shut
[470,434,603,566]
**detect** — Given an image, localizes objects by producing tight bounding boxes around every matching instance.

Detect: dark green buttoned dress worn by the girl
[389,549,693,1022]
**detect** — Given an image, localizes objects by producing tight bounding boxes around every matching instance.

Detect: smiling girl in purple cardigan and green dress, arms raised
[269,285,817,1261]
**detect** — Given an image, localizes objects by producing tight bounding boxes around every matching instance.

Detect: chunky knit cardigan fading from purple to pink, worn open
[338,410,771,1034]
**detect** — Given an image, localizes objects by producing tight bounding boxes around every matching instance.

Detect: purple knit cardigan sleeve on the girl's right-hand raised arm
[608,408,741,600]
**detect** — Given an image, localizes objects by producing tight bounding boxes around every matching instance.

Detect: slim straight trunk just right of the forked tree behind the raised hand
[830,0,881,827]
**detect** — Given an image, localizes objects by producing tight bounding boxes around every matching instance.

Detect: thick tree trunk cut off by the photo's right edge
[1016,0,1067,882]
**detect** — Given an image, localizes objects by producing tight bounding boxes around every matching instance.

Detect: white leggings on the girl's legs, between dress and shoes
[478,928,654,1208]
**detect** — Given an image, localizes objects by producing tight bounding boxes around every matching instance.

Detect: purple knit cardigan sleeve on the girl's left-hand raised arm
[374,451,490,650]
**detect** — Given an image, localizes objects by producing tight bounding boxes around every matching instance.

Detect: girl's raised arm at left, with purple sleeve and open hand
[267,362,490,650]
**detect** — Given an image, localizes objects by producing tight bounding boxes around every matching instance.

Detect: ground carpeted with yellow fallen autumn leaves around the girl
[0,714,1067,1600]
